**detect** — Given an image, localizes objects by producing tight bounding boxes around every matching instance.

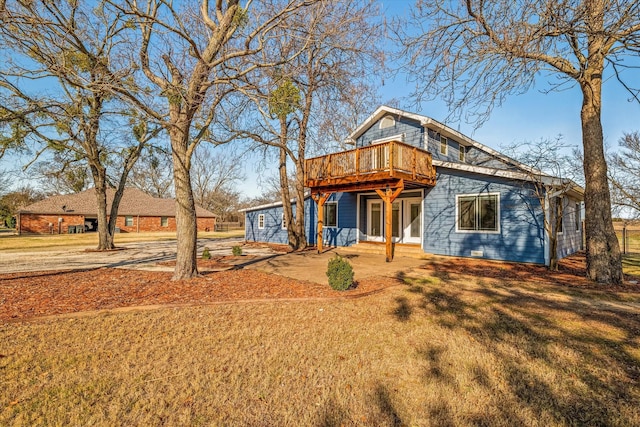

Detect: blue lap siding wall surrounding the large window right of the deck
[423,170,544,264]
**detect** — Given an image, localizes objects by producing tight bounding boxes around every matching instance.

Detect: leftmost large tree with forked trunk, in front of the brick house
[0,0,157,250]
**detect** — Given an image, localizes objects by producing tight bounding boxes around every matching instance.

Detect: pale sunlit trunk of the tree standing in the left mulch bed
[170,127,199,280]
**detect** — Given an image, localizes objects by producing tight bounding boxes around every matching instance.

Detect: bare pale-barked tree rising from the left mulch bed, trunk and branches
[112,0,316,280]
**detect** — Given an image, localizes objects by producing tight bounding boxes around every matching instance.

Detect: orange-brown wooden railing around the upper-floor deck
[305,141,435,183]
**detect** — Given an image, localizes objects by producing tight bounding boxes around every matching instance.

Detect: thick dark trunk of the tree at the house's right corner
[581,77,623,284]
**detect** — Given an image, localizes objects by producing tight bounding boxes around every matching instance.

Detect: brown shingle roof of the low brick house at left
[20,188,215,218]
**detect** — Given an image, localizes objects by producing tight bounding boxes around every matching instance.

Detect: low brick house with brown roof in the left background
[16,188,216,234]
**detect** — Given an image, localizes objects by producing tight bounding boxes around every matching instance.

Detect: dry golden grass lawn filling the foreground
[0,271,640,426]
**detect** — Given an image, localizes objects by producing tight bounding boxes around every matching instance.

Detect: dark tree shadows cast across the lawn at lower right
[391,271,640,425]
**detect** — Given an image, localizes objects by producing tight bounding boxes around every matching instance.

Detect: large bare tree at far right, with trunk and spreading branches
[396,0,640,284]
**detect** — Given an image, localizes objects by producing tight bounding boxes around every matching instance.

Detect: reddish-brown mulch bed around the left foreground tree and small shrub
[0,268,397,321]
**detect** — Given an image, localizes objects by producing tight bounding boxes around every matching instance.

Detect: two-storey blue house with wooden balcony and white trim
[245,106,584,265]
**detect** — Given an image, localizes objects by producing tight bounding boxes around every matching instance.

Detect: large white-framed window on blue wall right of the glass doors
[456,193,500,233]
